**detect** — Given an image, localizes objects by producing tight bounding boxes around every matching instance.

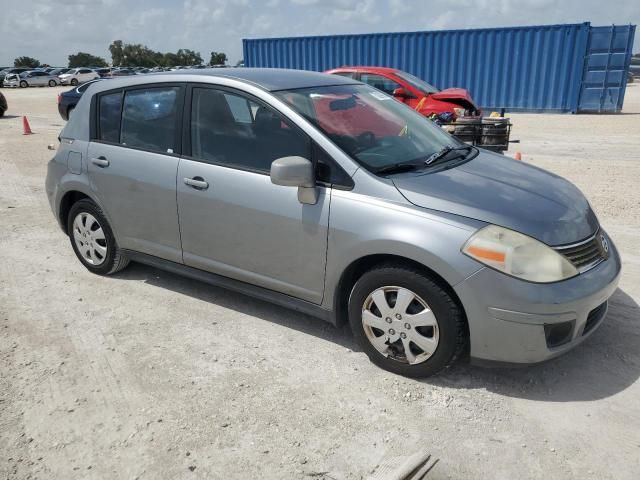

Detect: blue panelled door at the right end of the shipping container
[578,25,635,112]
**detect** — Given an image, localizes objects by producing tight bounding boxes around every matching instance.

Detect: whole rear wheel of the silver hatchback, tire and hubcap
[67,200,129,275]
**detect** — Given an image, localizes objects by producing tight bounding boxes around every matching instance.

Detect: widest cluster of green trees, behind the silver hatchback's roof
[109,40,202,67]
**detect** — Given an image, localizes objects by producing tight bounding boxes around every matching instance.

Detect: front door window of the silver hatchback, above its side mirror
[191,88,311,173]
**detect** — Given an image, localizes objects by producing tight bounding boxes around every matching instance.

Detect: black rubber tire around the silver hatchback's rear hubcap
[67,199,129,275]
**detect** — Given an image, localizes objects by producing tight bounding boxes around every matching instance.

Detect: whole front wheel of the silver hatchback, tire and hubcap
[349,264,467,377]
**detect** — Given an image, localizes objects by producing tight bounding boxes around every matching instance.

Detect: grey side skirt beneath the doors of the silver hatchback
[122,250,336,325]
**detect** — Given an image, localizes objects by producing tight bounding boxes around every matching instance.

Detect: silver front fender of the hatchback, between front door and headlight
[323,170,485,308]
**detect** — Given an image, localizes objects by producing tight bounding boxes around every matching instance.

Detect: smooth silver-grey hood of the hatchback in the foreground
[393,151,598,245]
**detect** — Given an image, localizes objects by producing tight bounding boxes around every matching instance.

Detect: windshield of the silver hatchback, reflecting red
[276,85,461,172]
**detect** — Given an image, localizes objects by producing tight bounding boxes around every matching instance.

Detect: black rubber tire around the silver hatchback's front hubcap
[349,264,467,378]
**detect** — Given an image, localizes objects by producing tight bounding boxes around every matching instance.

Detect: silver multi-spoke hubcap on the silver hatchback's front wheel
[362,286,440,365]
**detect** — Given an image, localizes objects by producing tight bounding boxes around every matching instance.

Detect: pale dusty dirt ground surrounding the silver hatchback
[0,84,640,480]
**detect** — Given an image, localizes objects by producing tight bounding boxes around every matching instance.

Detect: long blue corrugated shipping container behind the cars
[243,23,635,112]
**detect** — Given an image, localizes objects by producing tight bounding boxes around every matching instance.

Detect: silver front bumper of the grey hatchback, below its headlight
[455,232,621,364]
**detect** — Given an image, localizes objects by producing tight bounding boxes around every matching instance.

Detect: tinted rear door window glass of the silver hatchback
[120,87,180,153]
